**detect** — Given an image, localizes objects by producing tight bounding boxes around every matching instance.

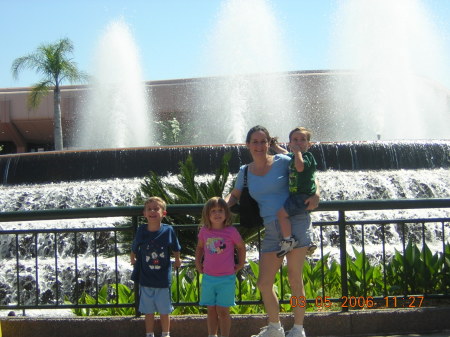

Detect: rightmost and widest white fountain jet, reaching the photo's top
[331,0,450,140]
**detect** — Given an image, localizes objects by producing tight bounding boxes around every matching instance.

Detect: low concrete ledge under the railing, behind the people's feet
[1,307,450,337]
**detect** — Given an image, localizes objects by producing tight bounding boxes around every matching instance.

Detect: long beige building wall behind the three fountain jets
[0,71,450,153]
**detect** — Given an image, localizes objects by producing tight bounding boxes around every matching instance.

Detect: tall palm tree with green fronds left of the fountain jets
[11,38,87,150]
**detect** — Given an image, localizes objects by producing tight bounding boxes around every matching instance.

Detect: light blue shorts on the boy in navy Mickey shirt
[139,286,173,315]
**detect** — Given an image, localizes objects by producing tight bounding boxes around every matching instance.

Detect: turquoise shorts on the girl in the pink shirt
[199,274,236,307]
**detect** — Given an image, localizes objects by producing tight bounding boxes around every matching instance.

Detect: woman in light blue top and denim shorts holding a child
[226,125,319,337]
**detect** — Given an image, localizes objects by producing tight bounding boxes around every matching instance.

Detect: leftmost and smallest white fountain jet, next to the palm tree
[75,21,154,149]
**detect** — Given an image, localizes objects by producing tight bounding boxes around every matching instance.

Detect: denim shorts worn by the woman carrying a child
[261,212,312,253]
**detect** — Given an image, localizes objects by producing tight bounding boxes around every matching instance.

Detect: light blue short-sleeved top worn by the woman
[235,154,291,224]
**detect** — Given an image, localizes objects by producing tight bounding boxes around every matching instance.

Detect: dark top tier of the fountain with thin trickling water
[0,140,450,185]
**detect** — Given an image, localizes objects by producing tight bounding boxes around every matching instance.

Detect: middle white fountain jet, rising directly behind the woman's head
[195,0,296,144]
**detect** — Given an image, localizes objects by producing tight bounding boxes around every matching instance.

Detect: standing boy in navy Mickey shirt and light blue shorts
[130,197,181,337]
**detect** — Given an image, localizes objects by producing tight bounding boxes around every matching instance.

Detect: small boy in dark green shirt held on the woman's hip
[273,127,317,257]
